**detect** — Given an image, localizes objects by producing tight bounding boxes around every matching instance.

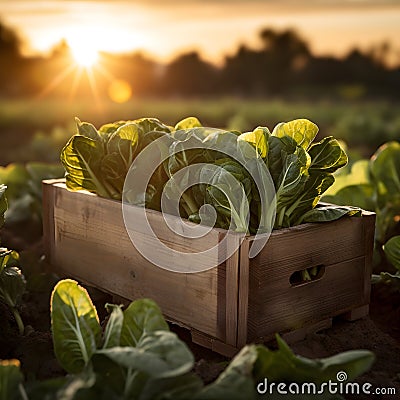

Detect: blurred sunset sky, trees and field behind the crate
[0,0,400,166]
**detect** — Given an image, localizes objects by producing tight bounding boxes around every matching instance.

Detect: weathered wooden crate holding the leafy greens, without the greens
[43,180,375,355]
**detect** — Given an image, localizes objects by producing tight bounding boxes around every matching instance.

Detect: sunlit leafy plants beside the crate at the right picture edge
[323,141,400,288]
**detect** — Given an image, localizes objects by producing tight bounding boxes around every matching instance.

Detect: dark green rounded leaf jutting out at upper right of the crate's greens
[308,136,348,173]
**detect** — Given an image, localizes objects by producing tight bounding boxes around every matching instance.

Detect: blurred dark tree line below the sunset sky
[0,22,400,99]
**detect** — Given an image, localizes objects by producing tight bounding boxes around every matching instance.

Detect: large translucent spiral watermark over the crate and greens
[122,128,276,273]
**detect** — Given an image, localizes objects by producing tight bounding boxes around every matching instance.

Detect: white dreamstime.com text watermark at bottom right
[257,371,396,396]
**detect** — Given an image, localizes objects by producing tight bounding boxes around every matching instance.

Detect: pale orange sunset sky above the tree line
[0,0,400,63]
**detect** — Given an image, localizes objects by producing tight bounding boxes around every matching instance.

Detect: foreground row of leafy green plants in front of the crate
[0,279,374,400]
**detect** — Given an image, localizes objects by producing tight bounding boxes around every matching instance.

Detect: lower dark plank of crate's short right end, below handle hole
[248,257,369,340]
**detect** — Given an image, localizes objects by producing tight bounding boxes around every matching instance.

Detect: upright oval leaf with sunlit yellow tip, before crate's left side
[51,279,101,373]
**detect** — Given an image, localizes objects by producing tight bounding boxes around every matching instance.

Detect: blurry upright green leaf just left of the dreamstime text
[194,345,258,400]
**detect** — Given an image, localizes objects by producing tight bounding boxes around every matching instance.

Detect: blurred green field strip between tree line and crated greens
[0,98,400,165]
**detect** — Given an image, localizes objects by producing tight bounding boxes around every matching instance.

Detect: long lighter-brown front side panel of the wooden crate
[50,183,225,340]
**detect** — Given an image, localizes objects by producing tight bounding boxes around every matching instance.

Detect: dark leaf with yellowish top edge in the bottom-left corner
[0,360,23,400]
